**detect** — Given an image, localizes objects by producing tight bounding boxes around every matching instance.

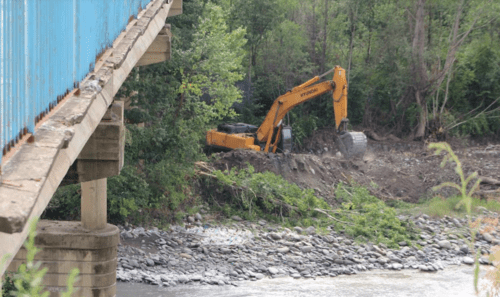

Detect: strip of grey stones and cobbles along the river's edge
[117,210,500,286]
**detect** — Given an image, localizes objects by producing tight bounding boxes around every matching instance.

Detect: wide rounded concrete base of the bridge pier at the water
[7,220,120,297]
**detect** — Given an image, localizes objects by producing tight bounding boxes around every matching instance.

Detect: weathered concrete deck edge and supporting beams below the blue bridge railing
[0,0,182,275]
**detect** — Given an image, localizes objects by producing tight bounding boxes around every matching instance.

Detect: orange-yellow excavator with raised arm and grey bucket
[206,66,366,159]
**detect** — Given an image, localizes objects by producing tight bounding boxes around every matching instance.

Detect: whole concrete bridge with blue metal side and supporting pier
[0,0,182,296]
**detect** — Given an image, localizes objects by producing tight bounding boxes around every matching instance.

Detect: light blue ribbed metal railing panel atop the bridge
[0,0,152,161]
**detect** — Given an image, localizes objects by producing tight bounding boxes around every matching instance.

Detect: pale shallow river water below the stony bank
[116,266,494,297]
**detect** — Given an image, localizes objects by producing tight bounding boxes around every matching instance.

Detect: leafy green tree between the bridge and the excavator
[109,1,246,219]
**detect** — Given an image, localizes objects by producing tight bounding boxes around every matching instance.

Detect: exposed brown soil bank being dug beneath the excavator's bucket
[212,129,500,202]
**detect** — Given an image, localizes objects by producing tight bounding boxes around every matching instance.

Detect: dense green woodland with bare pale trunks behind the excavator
[228,0,500,141]
